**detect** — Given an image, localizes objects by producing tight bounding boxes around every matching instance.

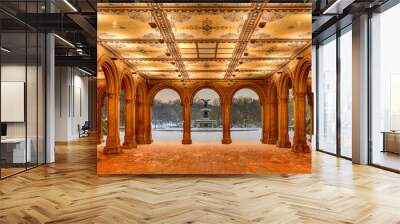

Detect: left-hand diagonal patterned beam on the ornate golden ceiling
[150,3,189,79]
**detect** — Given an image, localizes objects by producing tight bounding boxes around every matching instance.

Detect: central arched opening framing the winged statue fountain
[190,88,222,142]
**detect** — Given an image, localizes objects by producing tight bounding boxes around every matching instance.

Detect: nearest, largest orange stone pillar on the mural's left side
[104,93,122,153]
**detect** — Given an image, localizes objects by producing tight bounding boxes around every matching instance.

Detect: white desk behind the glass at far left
[1,138,32,163]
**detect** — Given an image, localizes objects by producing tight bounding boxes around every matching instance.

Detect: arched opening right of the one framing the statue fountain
[231,88,262,142]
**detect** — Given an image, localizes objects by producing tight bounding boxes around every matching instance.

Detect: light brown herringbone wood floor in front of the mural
[0,136,400,224]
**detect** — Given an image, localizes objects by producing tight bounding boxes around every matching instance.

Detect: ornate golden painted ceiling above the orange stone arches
[97,3,311,79]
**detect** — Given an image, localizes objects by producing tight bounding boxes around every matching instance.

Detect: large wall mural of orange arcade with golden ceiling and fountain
[97,2,313,174]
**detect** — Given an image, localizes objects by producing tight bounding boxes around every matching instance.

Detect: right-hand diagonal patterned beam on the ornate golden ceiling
[224,1,264,79]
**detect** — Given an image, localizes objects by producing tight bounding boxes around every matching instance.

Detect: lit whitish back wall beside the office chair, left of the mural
[55,67,88,141]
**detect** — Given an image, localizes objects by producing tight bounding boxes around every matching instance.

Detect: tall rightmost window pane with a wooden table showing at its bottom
[370,4,400,170]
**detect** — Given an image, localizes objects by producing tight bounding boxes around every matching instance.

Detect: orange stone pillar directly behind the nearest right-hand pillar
[276,97,291,148]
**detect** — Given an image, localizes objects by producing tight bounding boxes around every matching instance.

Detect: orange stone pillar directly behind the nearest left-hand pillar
[122,99,136,149]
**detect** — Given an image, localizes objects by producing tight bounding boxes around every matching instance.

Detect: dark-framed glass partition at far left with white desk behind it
[0,1,46,178]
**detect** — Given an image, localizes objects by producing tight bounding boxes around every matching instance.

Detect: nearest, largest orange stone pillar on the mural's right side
[292,93,310,152]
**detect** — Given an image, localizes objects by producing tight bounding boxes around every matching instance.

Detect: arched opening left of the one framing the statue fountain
[151,89,183,142]
